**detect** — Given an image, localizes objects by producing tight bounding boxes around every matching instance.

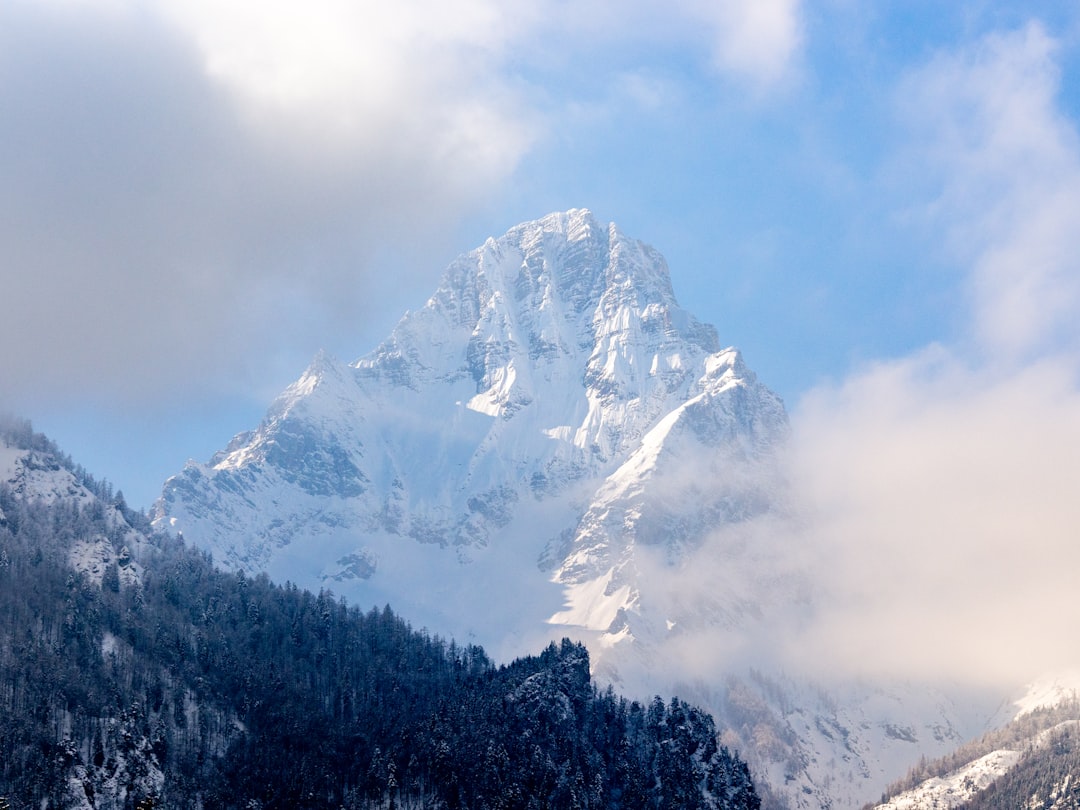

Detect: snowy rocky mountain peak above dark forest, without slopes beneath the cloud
[154,210,787,652]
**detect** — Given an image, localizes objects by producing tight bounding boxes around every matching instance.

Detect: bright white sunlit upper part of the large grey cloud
[156,0,528,163]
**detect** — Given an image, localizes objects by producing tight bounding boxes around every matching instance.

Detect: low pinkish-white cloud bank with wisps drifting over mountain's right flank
[636,347,1080,694]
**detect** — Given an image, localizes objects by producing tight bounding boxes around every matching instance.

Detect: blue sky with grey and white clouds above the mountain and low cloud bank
[0,0,1080,505]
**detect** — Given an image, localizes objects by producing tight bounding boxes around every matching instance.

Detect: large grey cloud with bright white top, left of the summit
[0,0,534,411]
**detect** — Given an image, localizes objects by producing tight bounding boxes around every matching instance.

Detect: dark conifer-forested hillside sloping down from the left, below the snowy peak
[0,421,759,810]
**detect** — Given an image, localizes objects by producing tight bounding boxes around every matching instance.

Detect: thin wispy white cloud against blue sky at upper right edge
[901,23,1080,359]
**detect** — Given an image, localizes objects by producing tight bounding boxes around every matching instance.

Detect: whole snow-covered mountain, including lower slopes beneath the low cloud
[153,210,1010,808]
